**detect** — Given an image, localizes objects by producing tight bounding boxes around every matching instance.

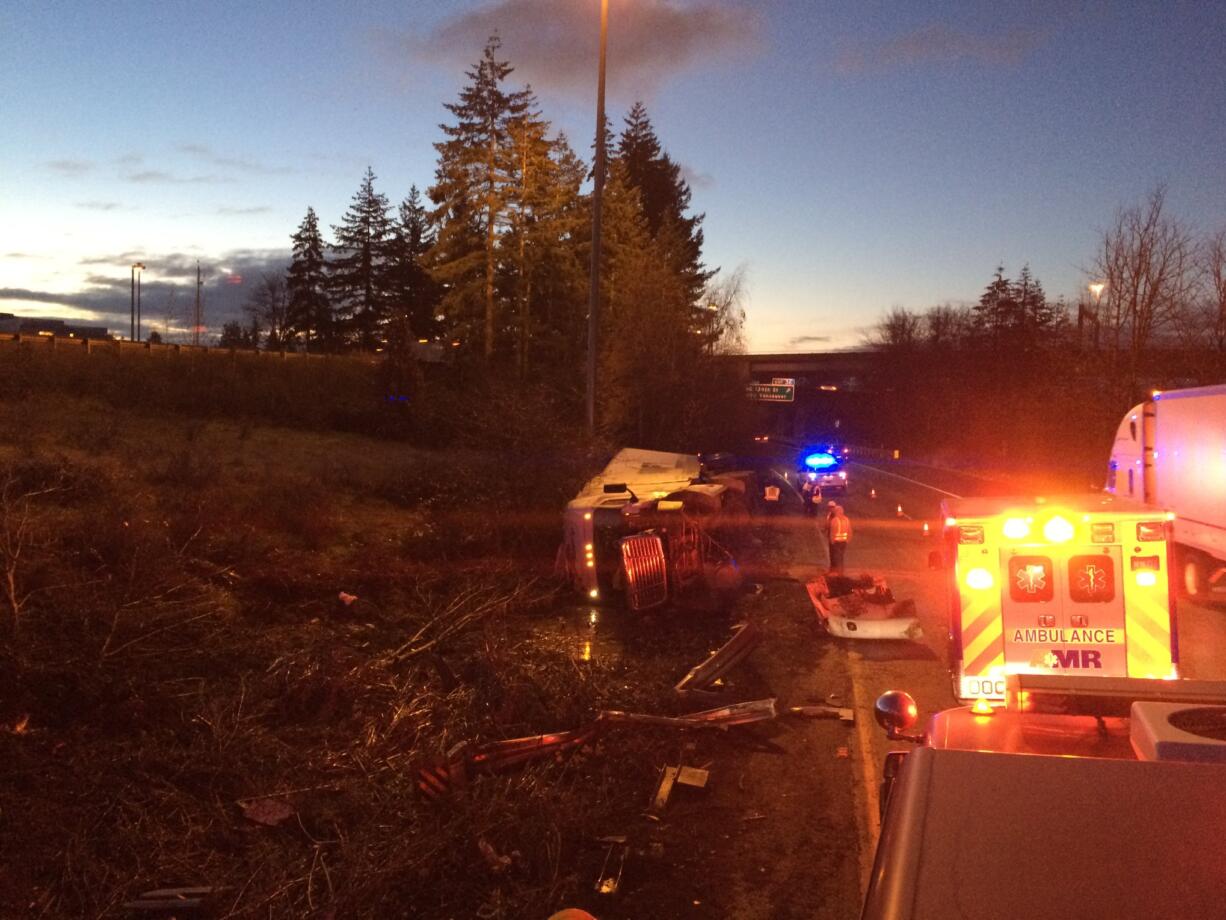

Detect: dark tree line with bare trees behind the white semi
[866,186,1226,478]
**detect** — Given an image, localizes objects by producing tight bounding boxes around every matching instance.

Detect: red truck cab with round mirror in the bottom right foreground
[862,675,1226,920]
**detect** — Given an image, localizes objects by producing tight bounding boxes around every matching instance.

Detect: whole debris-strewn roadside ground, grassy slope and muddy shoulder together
[0,395,859,920]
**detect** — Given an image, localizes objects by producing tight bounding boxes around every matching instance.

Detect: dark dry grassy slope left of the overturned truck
[0,394,730,918]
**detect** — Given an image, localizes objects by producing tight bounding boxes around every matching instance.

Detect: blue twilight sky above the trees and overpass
[0,0,1226,352]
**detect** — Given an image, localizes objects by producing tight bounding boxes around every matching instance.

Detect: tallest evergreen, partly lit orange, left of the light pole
[429,36,530,361]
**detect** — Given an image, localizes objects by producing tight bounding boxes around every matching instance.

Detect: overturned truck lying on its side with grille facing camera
[558,448,752,611]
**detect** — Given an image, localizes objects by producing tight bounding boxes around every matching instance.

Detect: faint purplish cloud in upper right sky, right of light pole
[835,23,1043,75]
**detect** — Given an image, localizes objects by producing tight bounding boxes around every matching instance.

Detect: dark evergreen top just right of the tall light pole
[617,102,714,308]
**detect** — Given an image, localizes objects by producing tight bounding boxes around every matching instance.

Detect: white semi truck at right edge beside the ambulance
[1107,384,1226,595]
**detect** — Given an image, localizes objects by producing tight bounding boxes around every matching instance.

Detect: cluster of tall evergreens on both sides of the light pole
[253,37,744,445]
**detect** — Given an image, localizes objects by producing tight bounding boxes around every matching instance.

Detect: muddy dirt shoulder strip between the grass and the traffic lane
[551,505,859,920]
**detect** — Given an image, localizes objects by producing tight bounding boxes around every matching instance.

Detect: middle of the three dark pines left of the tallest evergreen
[327,167,391,350]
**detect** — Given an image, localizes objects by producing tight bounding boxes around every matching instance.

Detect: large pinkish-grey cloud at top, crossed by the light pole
[395,0,761,94]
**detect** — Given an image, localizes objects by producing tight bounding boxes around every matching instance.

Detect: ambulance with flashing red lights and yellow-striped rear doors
[942,494,1178,700]
